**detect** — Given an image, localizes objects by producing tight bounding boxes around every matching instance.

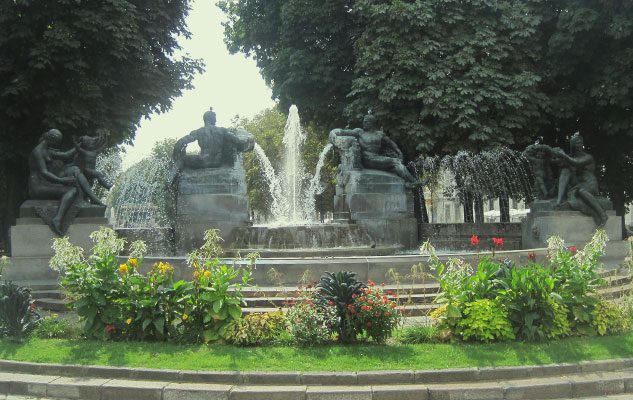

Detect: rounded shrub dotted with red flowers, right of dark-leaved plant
[348,280,402,343]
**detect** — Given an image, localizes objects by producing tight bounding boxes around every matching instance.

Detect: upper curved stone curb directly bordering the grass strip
[0,358,633,386]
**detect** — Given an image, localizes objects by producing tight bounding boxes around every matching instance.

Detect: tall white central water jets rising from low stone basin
[233,105,377,254]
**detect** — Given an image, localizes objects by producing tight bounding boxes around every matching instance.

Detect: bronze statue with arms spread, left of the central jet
[172,109,255,170]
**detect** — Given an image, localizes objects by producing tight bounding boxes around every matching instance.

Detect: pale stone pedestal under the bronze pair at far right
[522,198,622,248]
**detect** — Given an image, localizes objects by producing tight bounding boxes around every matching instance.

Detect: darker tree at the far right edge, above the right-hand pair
[541,0,633,216]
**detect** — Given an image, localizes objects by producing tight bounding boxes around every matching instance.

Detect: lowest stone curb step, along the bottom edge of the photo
[0,371,633,400]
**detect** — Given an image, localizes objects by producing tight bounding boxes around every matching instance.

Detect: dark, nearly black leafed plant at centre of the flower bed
[314,271,365,343]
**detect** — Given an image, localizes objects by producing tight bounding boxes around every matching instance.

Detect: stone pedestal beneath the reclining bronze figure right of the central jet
[334,169,418,248]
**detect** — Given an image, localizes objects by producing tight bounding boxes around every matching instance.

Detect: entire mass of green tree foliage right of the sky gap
[221,0,633,206]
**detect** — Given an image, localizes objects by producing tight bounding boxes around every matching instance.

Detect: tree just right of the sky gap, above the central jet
[218,0,356,126]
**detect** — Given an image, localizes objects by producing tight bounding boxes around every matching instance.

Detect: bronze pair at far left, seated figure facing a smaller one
[23,129,112,235]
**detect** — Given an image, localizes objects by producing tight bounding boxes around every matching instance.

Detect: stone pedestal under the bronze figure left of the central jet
[174,160,250,254]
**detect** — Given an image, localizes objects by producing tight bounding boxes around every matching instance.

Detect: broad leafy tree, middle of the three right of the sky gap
[347,0,547,156]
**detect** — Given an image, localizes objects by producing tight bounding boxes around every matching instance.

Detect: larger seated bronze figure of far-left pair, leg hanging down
[29,129,104,235]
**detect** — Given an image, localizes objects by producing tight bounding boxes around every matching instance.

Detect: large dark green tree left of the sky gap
[0,0,201,247]
